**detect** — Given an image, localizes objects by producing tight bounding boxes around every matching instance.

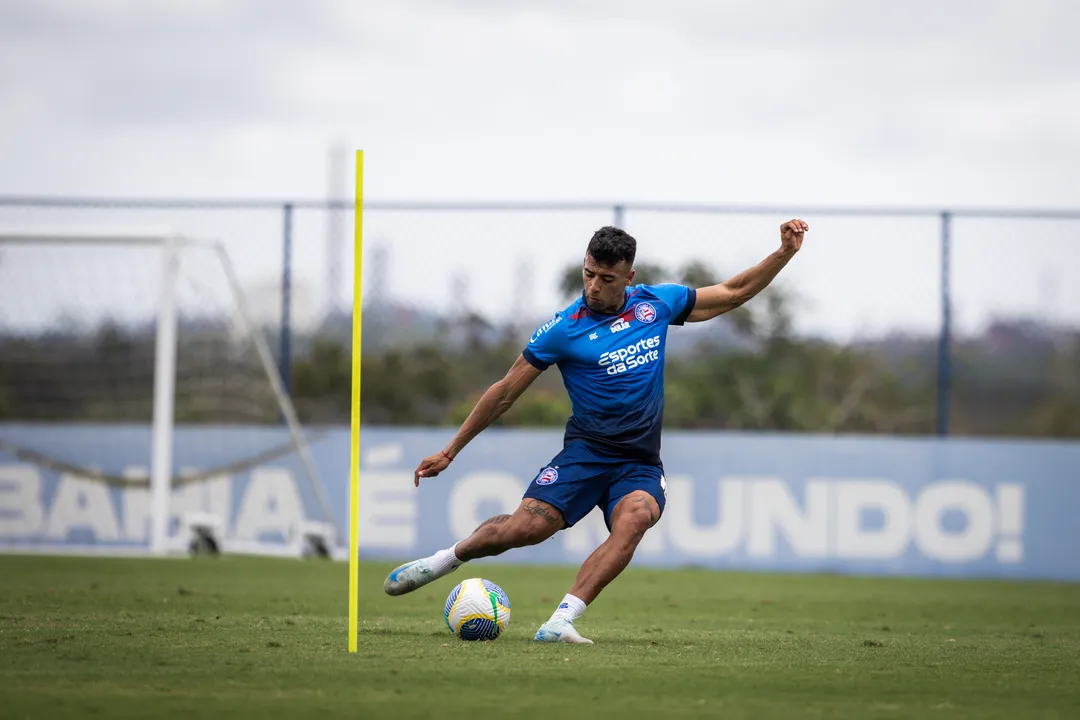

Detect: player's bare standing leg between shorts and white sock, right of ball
[570,490,660,604]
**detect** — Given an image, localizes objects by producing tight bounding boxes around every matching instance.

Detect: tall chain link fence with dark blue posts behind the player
[0,196,1080,437]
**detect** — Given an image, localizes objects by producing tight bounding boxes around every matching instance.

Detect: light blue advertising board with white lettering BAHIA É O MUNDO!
[0,424,1080,581]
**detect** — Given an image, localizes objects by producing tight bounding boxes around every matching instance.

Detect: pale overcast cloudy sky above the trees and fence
[0,0,1080,334]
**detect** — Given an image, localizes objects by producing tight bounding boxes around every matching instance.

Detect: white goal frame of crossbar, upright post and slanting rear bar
[0,228,341,555]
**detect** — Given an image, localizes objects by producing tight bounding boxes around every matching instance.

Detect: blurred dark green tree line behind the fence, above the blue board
[0,262,1080,437]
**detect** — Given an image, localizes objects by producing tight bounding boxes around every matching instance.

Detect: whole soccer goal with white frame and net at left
[0,230,337,554]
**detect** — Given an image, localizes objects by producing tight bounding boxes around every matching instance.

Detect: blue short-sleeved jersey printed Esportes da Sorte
[523,285,697,463]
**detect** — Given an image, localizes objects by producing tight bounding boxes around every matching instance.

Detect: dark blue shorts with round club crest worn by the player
[525,444,667,530]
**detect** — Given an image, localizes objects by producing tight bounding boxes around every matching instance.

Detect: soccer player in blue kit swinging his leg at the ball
[383,220,810,644]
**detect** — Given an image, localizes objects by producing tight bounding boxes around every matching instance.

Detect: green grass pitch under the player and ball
[0,556,1080,720]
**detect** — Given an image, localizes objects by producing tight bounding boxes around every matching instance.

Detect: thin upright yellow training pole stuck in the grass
[349,150,364,652]
